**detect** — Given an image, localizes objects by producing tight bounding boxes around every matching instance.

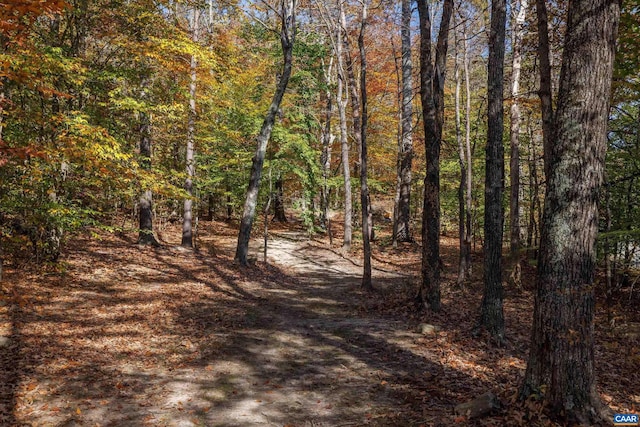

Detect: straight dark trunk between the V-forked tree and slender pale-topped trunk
[479,0,507,344]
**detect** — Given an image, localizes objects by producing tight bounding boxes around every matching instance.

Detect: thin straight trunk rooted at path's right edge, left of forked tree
[358,1,373,291]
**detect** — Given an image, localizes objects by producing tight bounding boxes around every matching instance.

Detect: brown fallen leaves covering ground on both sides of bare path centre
[0,223,640,426]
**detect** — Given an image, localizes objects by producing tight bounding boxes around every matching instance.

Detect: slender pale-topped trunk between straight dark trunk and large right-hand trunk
[509,0,528,263]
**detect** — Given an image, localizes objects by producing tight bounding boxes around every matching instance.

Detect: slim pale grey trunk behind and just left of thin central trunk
[336,0,352,252]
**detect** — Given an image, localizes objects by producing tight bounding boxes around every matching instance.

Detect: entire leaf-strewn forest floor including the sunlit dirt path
[0,216,640,427]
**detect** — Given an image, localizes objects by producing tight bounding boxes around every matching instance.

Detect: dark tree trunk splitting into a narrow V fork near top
[417,0,453,311]
